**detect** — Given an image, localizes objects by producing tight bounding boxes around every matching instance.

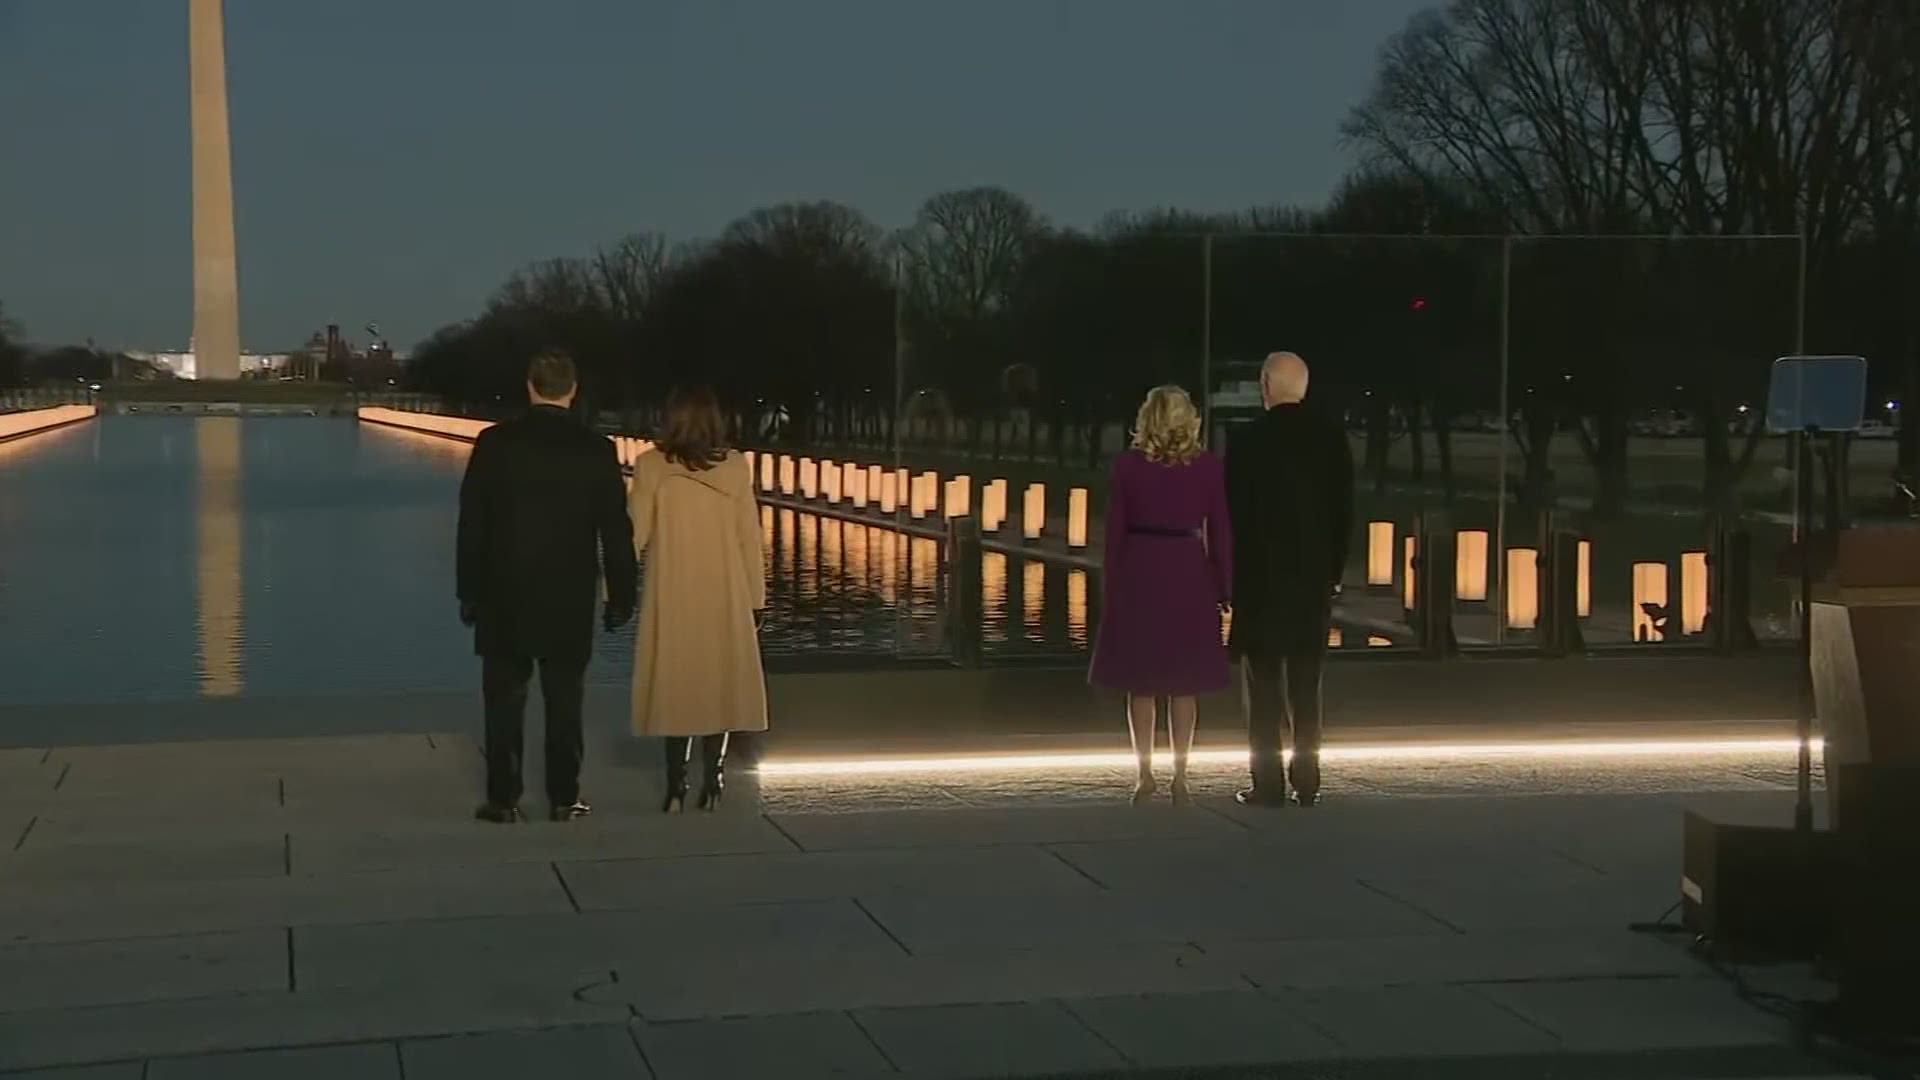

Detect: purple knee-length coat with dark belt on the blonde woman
[1091,450,1233,698]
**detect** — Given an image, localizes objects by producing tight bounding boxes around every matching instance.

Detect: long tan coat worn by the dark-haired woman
[628,452,766,736]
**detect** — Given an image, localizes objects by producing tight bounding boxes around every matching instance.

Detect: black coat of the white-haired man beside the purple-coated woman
[1227,405,1354,657]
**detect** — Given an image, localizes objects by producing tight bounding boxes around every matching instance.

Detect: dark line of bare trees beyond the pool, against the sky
[411,0,1920,507]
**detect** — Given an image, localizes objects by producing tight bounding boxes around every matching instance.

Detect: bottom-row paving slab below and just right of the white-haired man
[1269,986,1561,1057]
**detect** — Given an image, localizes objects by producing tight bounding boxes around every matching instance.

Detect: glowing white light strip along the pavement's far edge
[760,738,1822,778]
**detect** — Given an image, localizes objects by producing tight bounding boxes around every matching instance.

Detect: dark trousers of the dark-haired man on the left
[480,655,588,807]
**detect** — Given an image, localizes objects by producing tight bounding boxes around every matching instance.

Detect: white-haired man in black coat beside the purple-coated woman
[1227,352,1354,807]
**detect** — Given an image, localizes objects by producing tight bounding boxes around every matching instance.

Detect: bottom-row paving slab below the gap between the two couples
[852,1001,1125,1080]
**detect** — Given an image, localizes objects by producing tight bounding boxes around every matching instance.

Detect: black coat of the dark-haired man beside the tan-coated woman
[457,405,637,659]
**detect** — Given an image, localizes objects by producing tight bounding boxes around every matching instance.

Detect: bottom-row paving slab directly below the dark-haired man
[399,1024,651,1080]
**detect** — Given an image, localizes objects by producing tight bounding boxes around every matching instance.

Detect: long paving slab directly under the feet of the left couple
[292,805,793,872]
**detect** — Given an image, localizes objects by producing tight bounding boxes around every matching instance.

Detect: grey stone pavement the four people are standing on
[0,736,1866,1080]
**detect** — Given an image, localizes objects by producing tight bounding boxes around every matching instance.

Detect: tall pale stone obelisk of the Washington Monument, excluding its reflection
[188,0,240,379]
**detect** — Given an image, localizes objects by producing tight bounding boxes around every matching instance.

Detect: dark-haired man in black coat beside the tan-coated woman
[457,352,637,822]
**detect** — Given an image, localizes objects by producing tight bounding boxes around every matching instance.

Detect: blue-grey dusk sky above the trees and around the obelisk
[0,0,1432,350]
